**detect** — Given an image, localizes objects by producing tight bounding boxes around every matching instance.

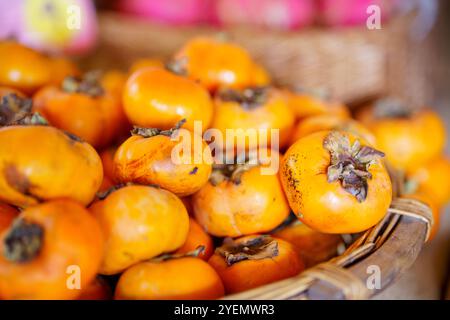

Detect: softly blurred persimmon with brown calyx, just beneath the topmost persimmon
[211,87,295,150]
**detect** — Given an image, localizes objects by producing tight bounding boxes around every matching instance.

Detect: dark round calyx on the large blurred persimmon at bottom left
[3,218,44,263]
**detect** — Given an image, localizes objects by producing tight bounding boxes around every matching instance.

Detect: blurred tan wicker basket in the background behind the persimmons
[83,13,431,105]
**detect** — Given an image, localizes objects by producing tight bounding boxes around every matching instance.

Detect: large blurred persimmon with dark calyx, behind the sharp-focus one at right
[357,99,446,171]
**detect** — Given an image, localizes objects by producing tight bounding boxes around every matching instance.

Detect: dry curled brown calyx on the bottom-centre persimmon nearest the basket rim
[216,236,278,266]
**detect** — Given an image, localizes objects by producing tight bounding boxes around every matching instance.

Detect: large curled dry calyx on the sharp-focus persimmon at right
[323,131,384,202]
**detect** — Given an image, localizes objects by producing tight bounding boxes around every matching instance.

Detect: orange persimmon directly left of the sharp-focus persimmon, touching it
[192,151,289,237]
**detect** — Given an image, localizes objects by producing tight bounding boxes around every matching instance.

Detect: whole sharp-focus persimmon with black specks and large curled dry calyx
[280,131,392,233]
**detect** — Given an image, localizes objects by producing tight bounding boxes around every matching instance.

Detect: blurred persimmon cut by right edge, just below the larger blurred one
[407,156,450,206]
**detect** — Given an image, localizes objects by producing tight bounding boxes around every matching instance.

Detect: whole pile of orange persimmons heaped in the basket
[0,37,450,299]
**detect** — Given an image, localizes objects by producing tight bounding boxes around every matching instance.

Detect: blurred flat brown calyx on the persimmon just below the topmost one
[218,87,269,110]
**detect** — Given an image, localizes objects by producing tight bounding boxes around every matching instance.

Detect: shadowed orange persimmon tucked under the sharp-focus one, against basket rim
[273,221,342,268]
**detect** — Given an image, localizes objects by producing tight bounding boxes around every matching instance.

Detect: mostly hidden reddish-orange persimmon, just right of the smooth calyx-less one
[176,218,214,260]
